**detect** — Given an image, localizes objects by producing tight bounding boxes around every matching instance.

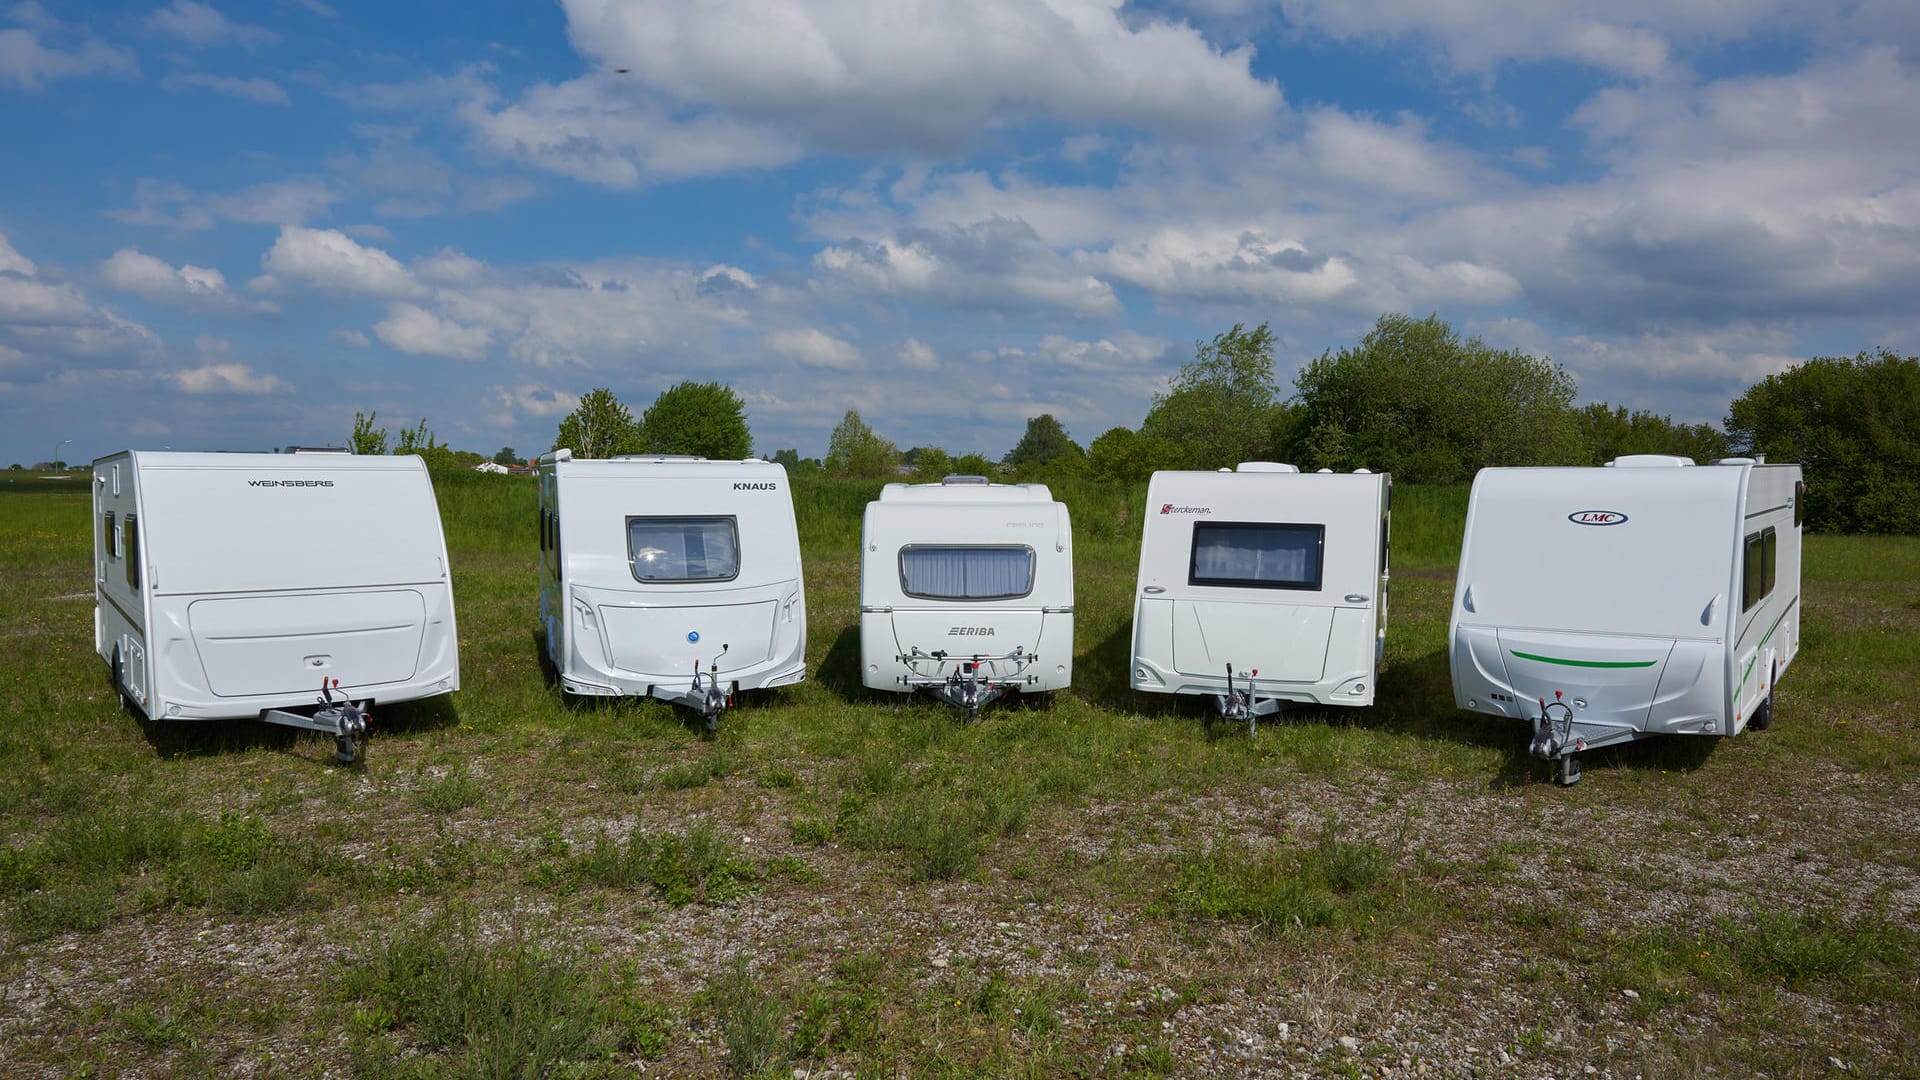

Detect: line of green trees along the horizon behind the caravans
[349,313,1920,532]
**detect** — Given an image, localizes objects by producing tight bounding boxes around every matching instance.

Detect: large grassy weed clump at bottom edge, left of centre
[340,917,622,1076]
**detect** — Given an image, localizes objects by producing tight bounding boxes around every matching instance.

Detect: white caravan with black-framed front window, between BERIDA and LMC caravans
[1131,461,1392,730]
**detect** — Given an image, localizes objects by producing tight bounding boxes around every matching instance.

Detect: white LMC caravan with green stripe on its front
[1448,455,1805,784]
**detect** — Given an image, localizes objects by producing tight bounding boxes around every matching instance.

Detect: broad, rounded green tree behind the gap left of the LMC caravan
[1292,315,1588,484]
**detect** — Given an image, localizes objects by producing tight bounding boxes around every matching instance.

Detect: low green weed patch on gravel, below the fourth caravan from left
[1167,840,1334,930]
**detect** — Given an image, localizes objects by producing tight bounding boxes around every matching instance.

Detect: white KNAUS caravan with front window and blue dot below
[540,450,806,728]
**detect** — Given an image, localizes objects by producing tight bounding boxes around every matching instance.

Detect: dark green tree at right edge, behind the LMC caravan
[1726,350,1920,534]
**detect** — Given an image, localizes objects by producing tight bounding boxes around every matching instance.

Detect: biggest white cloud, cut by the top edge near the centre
[564,0,1281,152]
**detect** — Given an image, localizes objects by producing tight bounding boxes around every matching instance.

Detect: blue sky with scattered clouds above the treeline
[0,0,1920,465]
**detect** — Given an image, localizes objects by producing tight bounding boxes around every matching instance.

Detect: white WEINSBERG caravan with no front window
[92,452,461,761]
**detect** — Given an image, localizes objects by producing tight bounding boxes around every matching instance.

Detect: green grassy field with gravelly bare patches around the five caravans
[0,475,1920,1078]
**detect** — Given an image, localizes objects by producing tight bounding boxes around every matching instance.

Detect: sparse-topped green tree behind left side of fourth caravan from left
[1140,323,1284,469]
